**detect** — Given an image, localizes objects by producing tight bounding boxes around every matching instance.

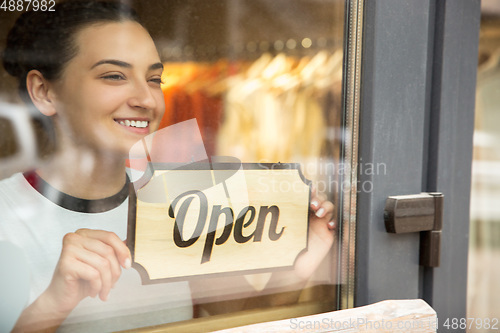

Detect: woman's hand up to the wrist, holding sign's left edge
[41,229,131,313]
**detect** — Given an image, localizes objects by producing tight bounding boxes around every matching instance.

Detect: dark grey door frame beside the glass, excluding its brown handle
[355,0,480,325]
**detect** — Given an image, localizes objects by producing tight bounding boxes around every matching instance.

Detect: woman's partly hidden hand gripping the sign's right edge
[294,189,336,280]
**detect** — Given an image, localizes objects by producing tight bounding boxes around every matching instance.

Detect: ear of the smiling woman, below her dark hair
[26,70,56,116]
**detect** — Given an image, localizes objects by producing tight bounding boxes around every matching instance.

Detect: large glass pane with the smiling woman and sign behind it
[0,0,362,331]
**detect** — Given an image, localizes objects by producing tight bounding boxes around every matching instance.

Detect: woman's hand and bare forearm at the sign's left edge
[13,229,131,332]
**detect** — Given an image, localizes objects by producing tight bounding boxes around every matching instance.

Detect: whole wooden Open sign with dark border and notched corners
[127,163,310,284]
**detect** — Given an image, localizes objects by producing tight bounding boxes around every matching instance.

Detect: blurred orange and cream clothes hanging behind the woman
[160,49,342,179]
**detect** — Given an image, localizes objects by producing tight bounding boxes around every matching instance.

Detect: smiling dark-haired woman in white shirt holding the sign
[0,1,333,331]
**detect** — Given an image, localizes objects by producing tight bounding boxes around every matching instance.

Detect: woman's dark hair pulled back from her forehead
[2,0,141,100]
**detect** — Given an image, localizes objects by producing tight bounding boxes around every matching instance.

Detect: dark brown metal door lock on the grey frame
[384,192,444,267]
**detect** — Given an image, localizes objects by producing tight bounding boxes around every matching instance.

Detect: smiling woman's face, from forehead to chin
[48,21,165,155]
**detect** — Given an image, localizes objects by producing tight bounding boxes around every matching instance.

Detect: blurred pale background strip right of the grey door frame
[467,0,500,332]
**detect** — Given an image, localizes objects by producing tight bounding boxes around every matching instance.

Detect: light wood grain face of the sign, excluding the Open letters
[134,169,309,279]
